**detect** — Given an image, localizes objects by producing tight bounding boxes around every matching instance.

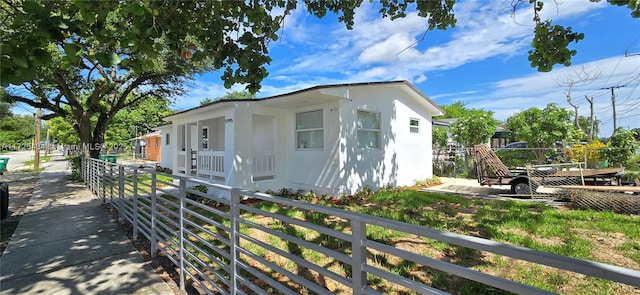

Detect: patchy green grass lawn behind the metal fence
[151,189,640,294]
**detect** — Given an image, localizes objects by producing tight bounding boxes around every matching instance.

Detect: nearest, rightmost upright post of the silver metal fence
[351,217,367,294]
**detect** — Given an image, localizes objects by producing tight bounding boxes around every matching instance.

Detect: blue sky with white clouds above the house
[175,0,640,137]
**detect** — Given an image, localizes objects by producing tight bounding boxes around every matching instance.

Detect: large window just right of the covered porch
[296,110,324,149]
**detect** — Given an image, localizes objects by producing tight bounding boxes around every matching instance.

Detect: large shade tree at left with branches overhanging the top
[0,0,640,157]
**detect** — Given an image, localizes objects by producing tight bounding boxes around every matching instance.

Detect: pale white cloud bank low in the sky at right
[456,56,640,136]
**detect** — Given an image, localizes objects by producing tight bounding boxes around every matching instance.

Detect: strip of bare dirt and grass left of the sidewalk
[0,173,39,255]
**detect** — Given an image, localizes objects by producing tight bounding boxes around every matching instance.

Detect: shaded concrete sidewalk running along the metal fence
[0,155,173,295]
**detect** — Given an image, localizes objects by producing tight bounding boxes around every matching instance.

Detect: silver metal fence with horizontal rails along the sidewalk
[82,158,640,295]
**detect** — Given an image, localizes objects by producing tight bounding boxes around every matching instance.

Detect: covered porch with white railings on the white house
[174,115,276,185]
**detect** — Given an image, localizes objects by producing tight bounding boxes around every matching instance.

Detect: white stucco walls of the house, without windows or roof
[162,85,435,195]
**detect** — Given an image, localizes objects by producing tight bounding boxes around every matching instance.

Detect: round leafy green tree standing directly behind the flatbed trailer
[507,103,584,164]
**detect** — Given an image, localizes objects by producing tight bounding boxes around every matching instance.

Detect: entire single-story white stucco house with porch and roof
[157,81,444,195]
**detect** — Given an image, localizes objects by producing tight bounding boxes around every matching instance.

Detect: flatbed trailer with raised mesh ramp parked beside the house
[473,144,624,195]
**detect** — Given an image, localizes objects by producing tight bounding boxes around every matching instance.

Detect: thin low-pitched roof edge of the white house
[164,80,444,120]
